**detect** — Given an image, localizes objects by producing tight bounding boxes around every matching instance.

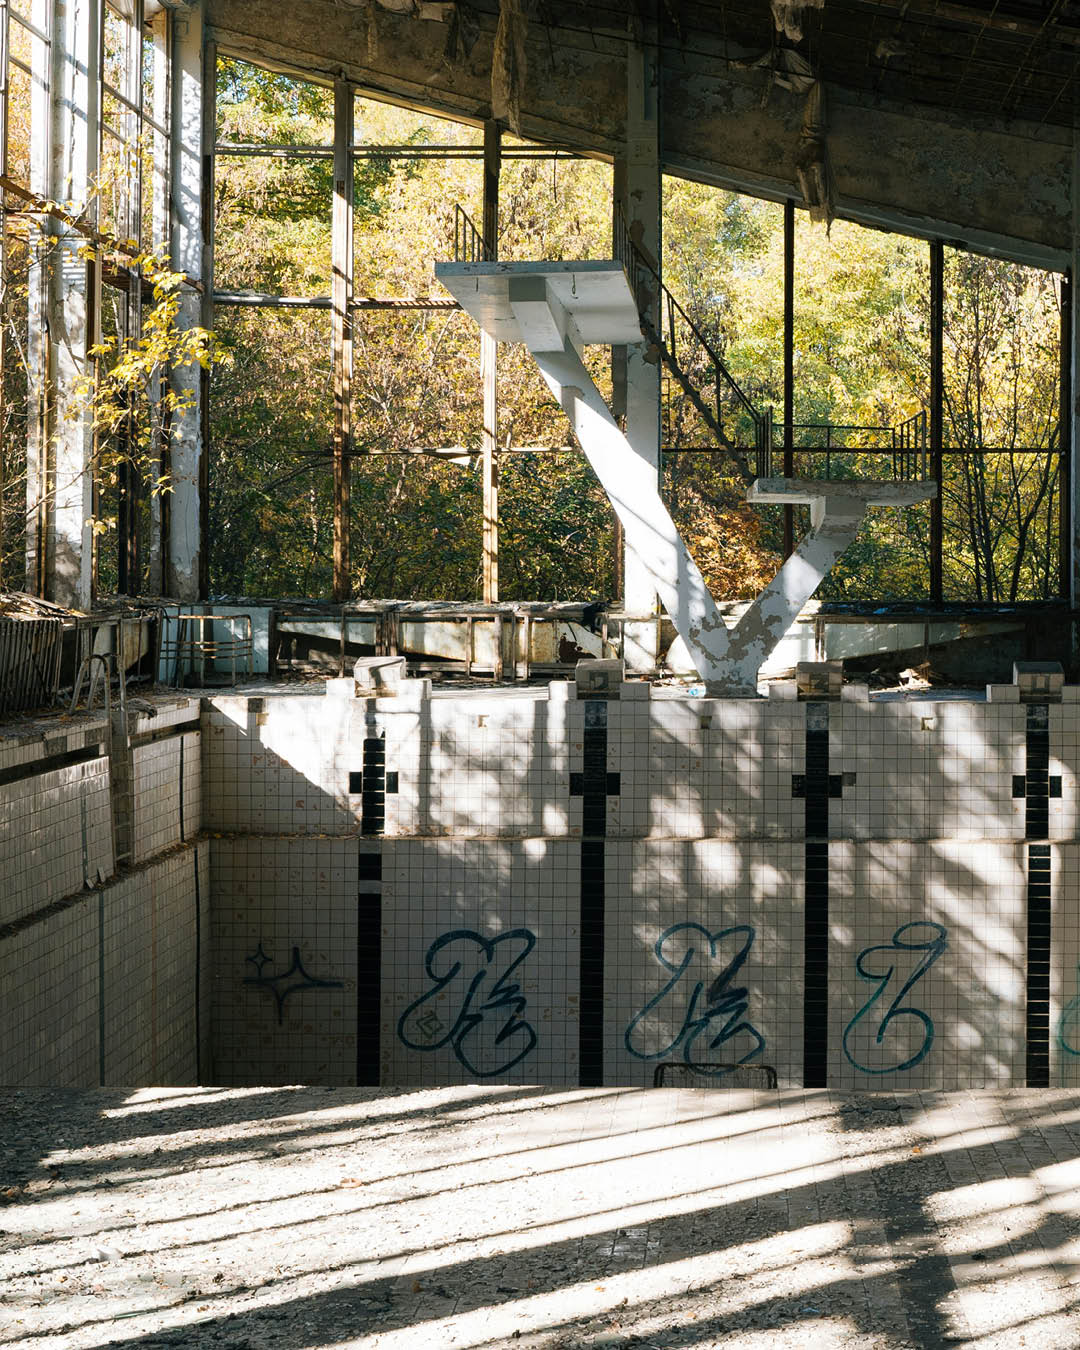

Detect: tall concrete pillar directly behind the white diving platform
[616,14,662,671]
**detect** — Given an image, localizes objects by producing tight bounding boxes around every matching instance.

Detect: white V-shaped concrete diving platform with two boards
[435,262,937,695]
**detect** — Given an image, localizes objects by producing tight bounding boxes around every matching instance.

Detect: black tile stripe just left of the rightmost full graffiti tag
[792,702,836,1088]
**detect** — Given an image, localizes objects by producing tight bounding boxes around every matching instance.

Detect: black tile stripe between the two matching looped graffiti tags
[583,699,614,1088]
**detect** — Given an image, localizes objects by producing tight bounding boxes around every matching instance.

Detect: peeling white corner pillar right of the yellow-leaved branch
[165,0,213,601]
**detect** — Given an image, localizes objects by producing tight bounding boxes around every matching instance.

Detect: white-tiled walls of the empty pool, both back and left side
[0,691,1080,1088]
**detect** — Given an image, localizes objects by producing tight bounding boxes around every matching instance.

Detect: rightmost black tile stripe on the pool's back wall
[1023,703,1060,1088]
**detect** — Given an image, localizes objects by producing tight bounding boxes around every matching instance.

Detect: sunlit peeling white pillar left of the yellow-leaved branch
[27,0,100,610]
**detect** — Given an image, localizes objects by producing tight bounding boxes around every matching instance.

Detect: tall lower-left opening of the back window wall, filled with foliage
[209,309,333,597]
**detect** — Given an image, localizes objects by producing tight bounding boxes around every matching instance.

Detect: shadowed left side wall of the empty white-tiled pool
[0,698,211,1087]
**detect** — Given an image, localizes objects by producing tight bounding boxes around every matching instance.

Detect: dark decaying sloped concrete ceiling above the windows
[208,0,1080,267]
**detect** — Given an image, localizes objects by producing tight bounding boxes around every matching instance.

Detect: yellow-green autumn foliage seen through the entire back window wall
[202,61,1057,599]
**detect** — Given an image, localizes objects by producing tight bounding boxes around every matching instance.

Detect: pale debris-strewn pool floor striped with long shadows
[0,1087,1080,1350]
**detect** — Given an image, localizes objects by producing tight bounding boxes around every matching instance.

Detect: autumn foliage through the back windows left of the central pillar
[211,72,616,599]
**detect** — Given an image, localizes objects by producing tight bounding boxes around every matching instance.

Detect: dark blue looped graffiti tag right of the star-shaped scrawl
[397,929,536,1079]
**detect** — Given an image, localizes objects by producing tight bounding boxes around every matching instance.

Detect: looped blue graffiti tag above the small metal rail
[622,923,765,1077]
